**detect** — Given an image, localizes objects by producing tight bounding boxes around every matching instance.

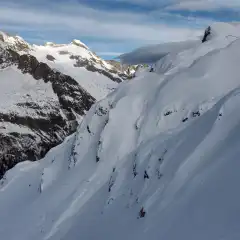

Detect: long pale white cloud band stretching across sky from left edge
[0,4,200,42]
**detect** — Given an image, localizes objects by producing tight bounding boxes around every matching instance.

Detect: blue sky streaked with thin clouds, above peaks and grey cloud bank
[0,0,240,58]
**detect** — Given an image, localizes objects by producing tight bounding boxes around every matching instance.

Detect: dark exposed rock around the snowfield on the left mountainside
[0,48,95,178]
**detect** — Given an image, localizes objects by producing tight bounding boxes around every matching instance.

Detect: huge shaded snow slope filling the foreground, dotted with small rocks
[0,24,240,240]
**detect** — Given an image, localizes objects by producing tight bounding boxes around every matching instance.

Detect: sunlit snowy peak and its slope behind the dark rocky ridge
[31,40,128,100]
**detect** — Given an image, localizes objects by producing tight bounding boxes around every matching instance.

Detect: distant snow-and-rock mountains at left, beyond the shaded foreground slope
[0,32,127,177]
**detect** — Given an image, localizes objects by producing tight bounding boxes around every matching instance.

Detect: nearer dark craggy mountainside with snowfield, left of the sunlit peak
[0,48,95,177]
